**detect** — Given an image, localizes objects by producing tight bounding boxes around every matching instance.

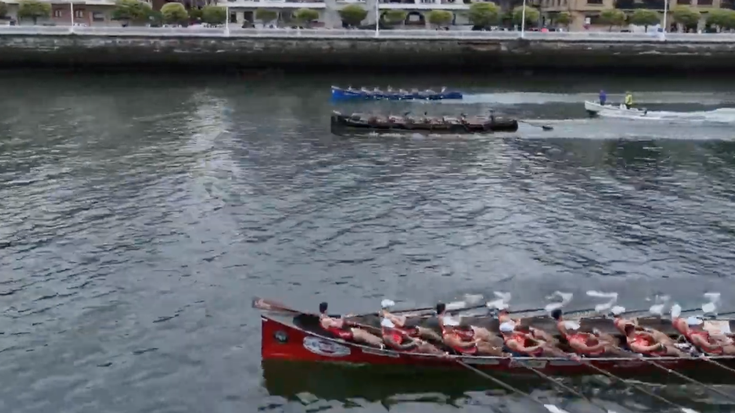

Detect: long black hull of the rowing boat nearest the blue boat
[331,113,518,135]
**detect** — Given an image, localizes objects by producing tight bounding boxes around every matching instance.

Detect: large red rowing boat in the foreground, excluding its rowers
[253,299,735,380]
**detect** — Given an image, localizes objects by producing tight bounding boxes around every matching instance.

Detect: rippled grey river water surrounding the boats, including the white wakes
[0,74,735,413]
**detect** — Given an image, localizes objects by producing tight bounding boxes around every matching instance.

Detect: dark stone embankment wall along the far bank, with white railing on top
[0,27,735,73]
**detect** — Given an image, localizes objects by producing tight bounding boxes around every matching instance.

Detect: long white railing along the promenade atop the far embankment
[0,26,735,43]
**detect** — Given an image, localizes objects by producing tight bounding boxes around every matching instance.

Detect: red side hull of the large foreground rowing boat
[261,316,733,377]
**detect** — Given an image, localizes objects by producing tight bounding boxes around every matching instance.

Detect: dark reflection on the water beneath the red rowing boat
[261,360,732,412]
